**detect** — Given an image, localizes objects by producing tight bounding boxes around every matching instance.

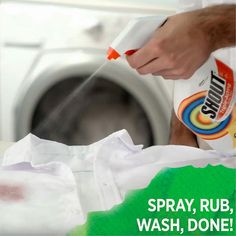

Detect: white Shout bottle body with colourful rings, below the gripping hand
[174,58,236,151]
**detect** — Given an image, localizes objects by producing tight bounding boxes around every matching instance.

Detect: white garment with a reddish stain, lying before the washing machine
[0,130,236,235]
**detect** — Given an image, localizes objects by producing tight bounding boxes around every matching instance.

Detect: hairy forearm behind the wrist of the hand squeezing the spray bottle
[196,4,236,51]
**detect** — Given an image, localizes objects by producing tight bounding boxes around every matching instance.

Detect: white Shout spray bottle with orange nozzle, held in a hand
[107,16,236,151]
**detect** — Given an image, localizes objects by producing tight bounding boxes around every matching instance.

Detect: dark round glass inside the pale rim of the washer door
[31,76,154,147]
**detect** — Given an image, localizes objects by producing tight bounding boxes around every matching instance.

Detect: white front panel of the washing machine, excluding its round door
[0,0,175,141]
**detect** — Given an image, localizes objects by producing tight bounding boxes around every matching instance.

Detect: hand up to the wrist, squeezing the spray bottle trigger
[127,10,220,79]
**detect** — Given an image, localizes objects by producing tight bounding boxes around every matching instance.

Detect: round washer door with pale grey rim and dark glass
[16,50,169,147]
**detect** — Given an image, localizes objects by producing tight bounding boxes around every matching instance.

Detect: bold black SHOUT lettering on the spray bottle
[201,71,226,120]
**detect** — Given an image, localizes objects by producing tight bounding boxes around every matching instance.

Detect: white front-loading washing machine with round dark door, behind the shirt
[0,0,175,146]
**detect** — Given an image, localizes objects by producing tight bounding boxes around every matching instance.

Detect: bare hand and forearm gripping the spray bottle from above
[127,4,236,79]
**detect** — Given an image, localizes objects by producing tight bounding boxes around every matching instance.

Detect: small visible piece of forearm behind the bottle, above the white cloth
[169,112,198,147]
